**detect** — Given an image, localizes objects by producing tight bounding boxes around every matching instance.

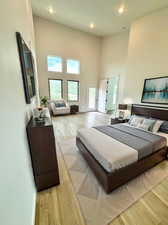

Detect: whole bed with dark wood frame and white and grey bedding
[76,105,168,193]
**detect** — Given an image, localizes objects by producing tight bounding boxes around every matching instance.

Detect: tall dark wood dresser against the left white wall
[27,118,59,191]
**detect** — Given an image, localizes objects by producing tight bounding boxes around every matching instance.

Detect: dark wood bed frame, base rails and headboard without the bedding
[76,105,168,193]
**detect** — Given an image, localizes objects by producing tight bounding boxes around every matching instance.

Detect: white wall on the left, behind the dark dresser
[0,0,36,225]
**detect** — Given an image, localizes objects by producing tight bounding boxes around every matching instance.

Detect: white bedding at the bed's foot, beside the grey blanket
[77,125,168,172]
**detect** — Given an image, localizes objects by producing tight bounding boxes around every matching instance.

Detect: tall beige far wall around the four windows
[34,17,100,111]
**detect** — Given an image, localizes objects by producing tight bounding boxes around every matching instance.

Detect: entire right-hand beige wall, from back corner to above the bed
[101,9,168,104]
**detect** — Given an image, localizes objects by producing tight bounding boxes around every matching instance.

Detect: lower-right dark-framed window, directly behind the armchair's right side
[68,80,79,101]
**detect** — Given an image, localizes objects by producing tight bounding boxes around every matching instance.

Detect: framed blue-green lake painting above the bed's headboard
[141,76,168,104]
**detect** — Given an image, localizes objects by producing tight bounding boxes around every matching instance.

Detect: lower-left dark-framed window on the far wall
[49,79,62,100]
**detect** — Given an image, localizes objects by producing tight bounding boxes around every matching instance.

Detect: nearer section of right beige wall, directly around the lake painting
[124,8,168,103]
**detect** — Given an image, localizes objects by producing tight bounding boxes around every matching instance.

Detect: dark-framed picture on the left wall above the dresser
[16,32,36,104]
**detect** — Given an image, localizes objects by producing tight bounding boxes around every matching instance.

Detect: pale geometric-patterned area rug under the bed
[58,138,168,225]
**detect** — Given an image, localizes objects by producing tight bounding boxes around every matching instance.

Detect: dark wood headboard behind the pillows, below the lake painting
[131,104,168,120]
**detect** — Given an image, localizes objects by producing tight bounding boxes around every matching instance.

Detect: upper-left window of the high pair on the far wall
[47,56,62,72]
